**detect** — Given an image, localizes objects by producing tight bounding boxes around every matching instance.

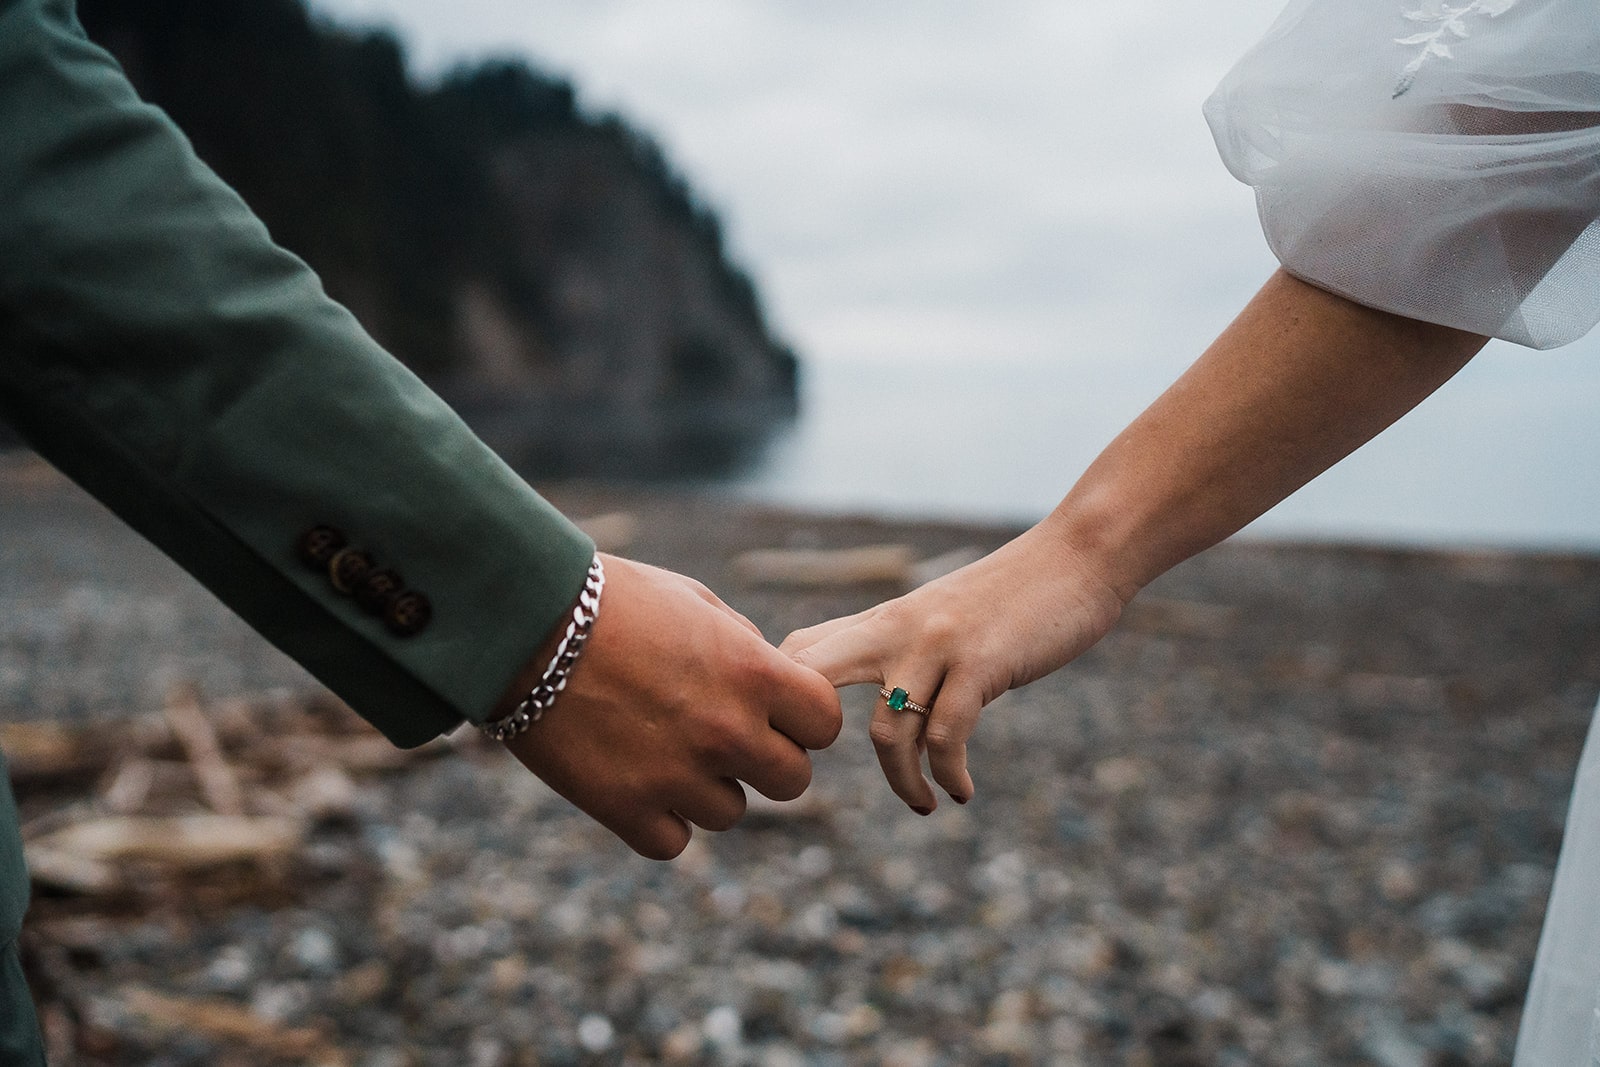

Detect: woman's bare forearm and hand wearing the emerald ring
[784,272,1486,813]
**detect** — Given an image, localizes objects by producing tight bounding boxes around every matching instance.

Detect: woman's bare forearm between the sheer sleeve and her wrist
[1062,270,1486,601]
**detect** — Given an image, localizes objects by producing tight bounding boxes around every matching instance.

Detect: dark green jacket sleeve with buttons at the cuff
[0,0,592,745]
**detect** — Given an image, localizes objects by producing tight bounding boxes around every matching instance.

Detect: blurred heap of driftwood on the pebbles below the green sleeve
[15,688,438,899]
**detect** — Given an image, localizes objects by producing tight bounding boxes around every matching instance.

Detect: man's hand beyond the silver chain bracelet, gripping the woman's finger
[506,557,842,859]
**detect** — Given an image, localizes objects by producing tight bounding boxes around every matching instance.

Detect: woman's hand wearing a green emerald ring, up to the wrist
[782,520,1123,814]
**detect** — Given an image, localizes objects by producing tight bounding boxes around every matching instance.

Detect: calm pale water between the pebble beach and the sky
[728,350,1600,550]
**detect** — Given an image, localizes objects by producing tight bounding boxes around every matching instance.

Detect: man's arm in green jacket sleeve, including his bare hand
[0,0,838,856]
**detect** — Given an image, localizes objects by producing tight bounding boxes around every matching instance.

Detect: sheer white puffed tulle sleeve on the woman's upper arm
[1205,0,1600,349]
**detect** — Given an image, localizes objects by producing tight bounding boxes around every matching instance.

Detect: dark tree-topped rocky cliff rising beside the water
[78,0,797,474]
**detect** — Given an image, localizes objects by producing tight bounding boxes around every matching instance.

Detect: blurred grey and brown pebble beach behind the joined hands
[0,466,1600,1067]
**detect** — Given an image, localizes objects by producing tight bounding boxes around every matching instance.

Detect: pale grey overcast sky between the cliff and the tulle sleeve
[308,0,1277,367]
